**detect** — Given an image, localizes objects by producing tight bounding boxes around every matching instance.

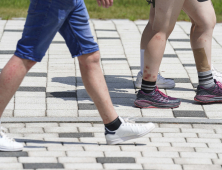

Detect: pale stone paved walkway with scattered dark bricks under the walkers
[0,20,222,170]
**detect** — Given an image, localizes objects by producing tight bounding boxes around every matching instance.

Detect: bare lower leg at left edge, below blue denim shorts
[0,55,36,116]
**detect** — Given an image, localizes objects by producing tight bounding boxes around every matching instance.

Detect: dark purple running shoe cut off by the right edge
[194,80,222,103]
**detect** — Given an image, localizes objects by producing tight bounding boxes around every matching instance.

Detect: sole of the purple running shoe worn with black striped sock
[134,100,181,109]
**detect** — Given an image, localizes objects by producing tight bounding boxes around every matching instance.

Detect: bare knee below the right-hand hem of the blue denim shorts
[79,52,100,68]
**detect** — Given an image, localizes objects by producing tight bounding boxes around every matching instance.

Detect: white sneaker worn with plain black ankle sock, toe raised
[105,117,155,145]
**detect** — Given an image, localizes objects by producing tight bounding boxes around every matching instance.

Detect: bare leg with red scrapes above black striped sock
[141,0,184,82]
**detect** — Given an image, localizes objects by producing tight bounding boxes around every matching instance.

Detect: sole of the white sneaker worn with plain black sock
[107,123,155,145]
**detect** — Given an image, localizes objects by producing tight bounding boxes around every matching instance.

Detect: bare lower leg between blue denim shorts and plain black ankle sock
[78,52,118,124]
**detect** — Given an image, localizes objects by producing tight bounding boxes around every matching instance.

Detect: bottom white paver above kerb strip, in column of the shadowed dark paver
[47,109,78,117]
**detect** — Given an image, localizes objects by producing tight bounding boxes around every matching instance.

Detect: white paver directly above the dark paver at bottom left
[18,157,57,163]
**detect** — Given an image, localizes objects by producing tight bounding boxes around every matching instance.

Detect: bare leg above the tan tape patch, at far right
[183,0,216,66]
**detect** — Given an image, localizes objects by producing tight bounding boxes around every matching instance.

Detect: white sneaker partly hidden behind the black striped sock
[135,71,175,89]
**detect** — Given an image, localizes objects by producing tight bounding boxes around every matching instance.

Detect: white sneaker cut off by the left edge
[0,127,23,151]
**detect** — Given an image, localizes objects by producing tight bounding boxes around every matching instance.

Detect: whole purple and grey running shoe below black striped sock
[134,87,180,108]
